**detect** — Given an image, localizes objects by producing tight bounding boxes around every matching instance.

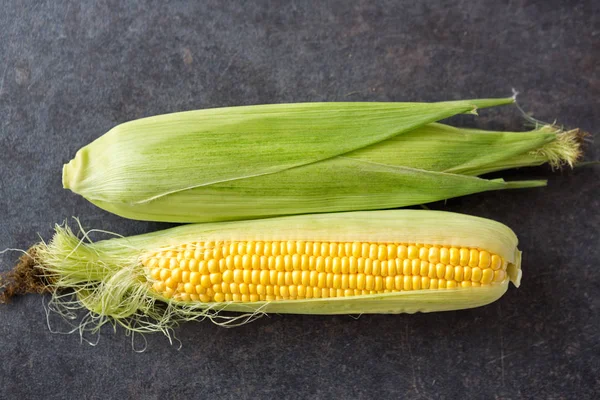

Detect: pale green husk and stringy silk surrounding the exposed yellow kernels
[16,210,521,335]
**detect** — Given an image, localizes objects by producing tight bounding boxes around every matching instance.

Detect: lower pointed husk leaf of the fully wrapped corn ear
[92,157,545,222]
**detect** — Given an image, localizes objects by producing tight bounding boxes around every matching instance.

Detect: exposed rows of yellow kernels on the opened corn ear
[141,240,508,302]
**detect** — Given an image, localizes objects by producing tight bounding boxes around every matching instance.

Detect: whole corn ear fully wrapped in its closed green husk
[63,98,579,222]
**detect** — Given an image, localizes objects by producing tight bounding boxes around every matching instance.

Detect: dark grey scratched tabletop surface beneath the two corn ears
[0,0,600,399]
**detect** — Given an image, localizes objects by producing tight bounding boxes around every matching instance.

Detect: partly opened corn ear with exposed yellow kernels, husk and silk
[14,210,521,331]
